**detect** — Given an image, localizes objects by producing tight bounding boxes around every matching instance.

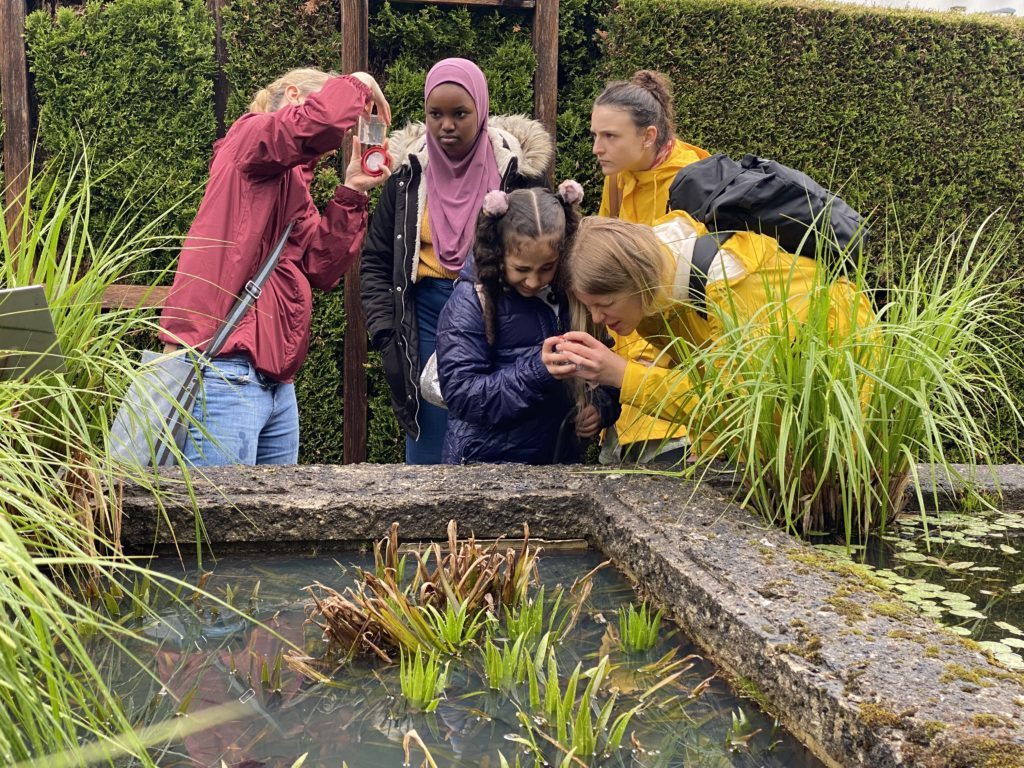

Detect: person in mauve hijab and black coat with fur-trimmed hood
[360,58,554,464]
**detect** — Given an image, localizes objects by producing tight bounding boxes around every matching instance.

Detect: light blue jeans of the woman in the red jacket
[184,356,299,467]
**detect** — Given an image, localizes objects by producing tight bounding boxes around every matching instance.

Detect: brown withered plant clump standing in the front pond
[306,520,544,663]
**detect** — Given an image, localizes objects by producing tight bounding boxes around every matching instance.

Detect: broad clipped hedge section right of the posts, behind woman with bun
[605,0,1024,249]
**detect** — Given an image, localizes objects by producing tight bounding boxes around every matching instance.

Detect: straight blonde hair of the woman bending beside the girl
[565,216,669,333]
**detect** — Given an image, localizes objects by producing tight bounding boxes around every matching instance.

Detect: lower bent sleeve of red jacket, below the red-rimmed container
[302,185,370,291]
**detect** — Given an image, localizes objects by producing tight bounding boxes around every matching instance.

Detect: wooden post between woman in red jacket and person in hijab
[341,0,370,464]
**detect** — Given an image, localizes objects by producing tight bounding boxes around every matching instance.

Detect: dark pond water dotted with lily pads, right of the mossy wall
[822,510,1024,669]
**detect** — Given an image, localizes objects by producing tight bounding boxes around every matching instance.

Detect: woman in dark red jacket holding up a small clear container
[160,69,391,466]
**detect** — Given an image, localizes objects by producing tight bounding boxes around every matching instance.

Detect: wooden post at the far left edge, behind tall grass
[0,0,31,252]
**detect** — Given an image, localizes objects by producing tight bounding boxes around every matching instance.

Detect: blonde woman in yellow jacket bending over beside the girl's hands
[541,211,871,423]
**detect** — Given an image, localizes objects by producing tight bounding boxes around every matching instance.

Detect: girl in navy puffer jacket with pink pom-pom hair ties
[437,181,618,464]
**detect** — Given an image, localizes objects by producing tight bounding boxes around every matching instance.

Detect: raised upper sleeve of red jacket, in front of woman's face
[238,75,370,177]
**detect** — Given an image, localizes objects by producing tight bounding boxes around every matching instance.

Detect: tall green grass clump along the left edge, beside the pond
[0,157,228,766]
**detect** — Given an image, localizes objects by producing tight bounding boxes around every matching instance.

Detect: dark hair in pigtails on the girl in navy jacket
[473,187,580,346]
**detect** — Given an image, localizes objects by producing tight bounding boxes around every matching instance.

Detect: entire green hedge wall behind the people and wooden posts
[22,0,1024,462]
